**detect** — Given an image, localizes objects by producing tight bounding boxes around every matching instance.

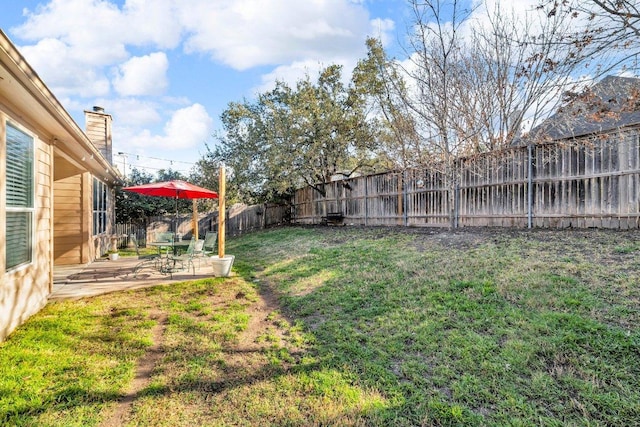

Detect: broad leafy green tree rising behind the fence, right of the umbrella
[199,65,378,203]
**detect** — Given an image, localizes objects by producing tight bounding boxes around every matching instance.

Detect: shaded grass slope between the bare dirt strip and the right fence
[229,229,640,425]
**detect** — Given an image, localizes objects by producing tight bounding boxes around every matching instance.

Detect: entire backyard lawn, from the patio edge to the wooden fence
[0,227,640,426]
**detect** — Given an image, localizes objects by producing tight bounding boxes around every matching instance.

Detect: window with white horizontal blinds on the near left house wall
[5,124,35,270]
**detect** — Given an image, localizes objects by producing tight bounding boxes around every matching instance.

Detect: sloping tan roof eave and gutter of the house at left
[0,30,122,183]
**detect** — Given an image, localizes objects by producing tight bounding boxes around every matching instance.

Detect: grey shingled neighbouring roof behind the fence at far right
[527,76,640,140]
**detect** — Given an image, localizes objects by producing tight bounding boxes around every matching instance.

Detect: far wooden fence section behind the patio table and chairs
[139,203,291,241]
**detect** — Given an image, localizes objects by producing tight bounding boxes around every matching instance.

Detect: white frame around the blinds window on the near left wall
[5,120,37,272]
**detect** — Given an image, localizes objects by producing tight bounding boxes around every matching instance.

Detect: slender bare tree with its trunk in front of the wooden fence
[390,0,476,224]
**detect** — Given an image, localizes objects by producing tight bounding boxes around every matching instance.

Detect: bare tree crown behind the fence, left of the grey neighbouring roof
[465,3,581,147]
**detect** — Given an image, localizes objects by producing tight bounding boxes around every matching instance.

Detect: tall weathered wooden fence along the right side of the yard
[292,129,640,229]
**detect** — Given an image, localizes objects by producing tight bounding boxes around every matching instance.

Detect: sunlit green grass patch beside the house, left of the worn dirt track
[0,300,153,426]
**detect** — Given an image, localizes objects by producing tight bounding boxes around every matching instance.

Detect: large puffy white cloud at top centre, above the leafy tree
[180,0,378,70]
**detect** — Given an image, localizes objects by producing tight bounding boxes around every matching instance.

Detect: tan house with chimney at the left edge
[0,31,121,341]
